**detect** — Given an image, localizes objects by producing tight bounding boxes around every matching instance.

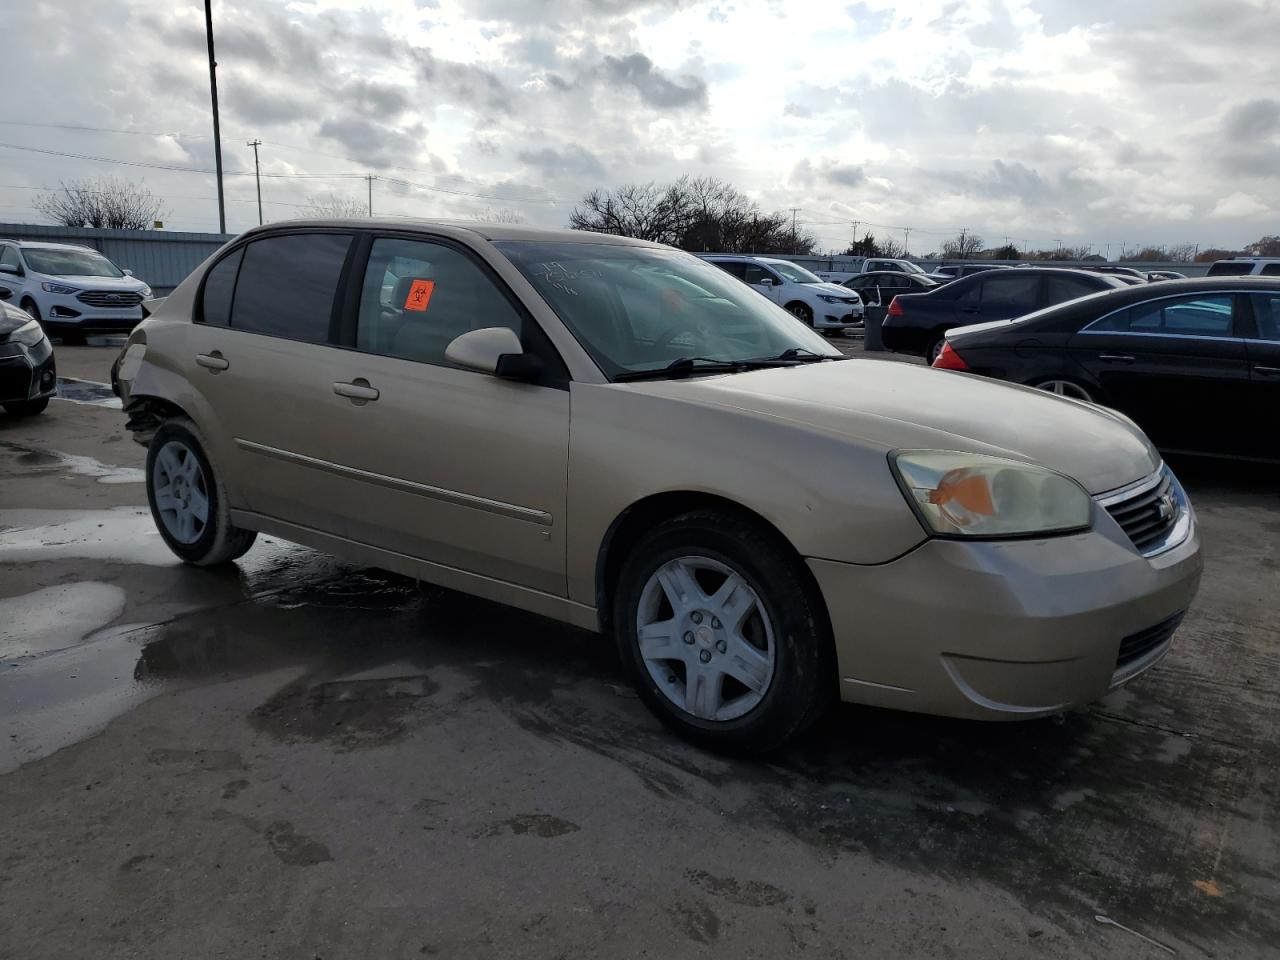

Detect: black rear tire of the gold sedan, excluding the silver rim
[147,417,257,567]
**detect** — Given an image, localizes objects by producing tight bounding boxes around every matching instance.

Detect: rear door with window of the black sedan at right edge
[1070,293,1249,453]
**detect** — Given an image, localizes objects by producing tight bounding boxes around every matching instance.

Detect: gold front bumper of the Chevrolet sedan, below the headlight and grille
[808,507,1202,719]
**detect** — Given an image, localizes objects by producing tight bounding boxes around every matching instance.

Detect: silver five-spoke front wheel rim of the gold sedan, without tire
[636,557,777,721]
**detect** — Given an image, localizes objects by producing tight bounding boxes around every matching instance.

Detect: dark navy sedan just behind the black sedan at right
[881,266,1128,362]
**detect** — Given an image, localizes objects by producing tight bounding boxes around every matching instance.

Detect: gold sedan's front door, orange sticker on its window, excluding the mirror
[312,237,570,596]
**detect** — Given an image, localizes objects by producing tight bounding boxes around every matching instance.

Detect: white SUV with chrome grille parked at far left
[0,239,151,343]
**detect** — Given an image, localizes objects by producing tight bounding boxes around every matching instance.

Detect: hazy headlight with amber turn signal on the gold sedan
[890,451,1093,538]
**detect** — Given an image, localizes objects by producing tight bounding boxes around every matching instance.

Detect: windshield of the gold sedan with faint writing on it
[494,241,842,379]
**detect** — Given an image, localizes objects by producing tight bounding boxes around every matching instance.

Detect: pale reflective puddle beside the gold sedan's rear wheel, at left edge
[0,507,180,567]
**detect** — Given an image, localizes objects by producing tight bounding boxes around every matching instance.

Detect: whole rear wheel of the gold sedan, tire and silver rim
[147,417,257,567]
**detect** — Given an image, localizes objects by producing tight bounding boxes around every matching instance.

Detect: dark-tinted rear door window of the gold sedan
[232,233,351,343]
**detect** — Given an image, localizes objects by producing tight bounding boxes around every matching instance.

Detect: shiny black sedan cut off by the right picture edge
[934,276,1280,461]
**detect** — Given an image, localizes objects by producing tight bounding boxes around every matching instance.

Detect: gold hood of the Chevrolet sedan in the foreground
[620,360,1160,494]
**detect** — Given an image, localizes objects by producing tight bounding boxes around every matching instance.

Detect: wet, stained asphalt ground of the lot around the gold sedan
[0,346,1280,960]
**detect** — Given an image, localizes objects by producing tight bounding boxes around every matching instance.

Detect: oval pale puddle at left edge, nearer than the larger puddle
[0,581,125,660]
